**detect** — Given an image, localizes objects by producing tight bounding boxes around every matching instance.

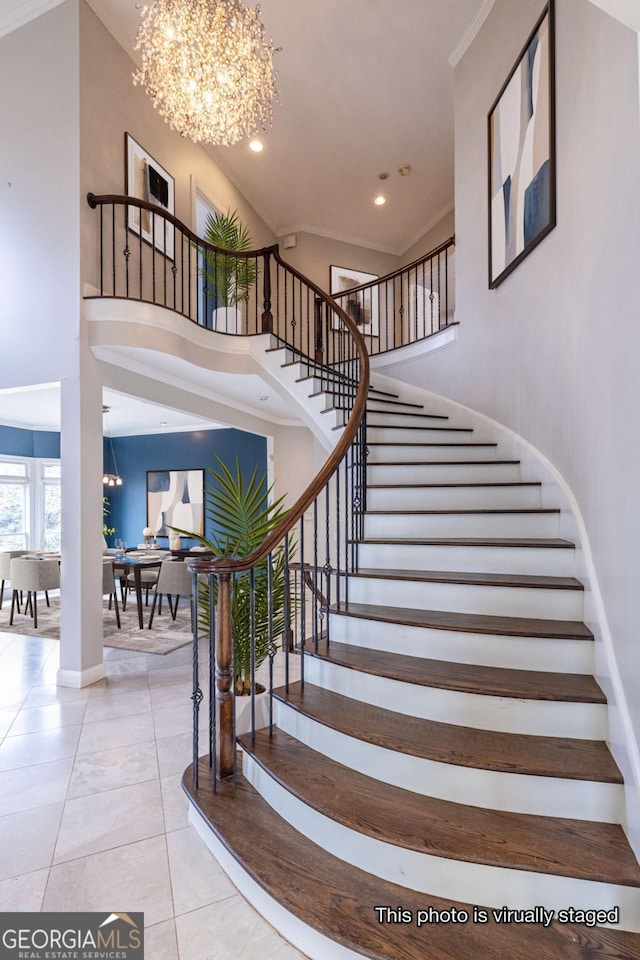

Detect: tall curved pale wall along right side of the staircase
[392,0,640,845]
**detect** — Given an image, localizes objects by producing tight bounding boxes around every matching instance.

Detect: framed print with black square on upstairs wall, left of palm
[124,133,175,260]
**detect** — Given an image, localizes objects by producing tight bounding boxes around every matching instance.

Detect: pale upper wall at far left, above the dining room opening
[0,0,80,387]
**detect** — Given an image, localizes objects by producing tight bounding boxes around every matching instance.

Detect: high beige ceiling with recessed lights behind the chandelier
[85,0,493,254]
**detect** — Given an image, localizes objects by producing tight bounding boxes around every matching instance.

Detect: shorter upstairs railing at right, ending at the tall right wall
[332,237,455,355]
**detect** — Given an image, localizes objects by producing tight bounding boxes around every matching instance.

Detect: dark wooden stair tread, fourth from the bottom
[305,639,607,703]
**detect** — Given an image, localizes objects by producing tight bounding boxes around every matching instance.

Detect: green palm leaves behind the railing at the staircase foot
[178,457,294,694]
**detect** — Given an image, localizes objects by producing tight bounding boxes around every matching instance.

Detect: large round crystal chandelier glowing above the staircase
[133,0,276,146]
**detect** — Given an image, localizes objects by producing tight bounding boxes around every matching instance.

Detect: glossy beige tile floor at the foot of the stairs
[0,632,302,960]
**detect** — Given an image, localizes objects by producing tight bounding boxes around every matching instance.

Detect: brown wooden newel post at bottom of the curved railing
[216,573,235,780]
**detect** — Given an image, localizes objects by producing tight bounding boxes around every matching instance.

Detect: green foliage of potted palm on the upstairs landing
[202,210,258,307]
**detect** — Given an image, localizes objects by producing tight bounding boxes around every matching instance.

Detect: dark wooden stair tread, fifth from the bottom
[331,602,593,640]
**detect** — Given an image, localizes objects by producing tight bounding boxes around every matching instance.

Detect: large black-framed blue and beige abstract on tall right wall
[488,0,556,289]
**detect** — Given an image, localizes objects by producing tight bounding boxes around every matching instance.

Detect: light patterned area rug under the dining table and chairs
[0,594,199,655]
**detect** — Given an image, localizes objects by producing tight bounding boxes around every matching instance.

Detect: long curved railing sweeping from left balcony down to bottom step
[88,194,369,790]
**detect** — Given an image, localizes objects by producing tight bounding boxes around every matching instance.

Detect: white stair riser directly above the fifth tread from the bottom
[349,576,584,620]
